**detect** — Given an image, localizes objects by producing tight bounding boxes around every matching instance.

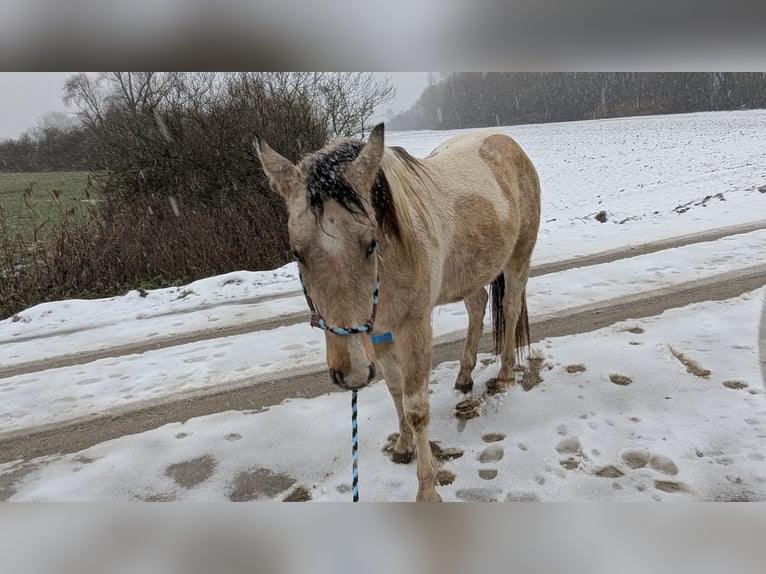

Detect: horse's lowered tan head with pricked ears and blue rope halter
[256,124,384,389]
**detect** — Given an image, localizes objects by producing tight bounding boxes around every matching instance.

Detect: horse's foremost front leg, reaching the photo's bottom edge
[396,322,441,502]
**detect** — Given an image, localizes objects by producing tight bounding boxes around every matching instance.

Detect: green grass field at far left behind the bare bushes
[0,171,94,239]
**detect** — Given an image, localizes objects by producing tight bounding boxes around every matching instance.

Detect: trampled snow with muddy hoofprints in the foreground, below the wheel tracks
[0,289,766,501]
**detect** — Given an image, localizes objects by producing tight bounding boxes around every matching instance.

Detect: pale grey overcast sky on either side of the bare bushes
[0,72,427,140]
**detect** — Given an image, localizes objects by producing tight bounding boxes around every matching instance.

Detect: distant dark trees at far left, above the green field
[0,126,93,172]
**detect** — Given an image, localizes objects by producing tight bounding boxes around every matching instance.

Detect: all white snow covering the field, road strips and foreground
[0,111,766,501]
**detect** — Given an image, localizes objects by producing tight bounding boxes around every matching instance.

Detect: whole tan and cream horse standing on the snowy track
[256,124,540,501]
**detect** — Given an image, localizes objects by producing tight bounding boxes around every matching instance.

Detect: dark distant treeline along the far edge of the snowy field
[388,72,766,129]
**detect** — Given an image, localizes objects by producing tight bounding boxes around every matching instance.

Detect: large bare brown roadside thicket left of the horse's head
[0,72,391,317]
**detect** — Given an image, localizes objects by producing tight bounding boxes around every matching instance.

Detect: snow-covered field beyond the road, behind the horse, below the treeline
[387,110,766,263]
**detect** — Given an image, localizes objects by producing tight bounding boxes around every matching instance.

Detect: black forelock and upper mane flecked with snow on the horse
[301,140,406,237]
